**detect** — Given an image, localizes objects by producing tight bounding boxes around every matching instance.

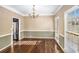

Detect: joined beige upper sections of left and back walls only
[0,6,54,39]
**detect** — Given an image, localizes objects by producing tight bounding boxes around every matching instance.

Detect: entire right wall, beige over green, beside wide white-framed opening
[54,5,73,51]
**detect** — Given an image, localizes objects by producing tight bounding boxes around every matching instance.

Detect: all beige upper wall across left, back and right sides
[0,5,72,35]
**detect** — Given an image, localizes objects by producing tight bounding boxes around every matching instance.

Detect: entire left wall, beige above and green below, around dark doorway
[0,6,24,50]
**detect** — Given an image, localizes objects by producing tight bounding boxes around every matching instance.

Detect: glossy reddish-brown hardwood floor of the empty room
[2,38,63,53]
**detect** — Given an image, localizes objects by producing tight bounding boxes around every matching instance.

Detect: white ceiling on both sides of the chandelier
[3,5,62,16]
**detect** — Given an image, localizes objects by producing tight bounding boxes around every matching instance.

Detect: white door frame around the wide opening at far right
[64,6,79,52]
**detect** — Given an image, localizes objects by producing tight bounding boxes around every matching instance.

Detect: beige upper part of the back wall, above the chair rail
[24,16,54,31]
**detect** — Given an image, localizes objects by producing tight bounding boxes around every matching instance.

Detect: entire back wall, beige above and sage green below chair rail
[24,16,54,38]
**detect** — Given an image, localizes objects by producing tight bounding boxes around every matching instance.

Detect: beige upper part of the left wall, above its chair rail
[0,6,23,35]
